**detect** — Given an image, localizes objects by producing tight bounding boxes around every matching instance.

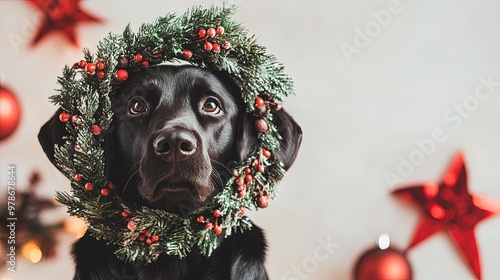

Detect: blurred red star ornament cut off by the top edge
[30,0,101,46]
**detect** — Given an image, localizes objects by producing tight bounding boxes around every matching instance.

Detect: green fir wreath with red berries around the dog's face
[51,6,293,262]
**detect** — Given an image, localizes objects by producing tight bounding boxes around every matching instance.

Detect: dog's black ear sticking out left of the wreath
[38,109,67,170]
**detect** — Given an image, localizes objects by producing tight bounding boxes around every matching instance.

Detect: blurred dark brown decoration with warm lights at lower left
[0,172,64,267]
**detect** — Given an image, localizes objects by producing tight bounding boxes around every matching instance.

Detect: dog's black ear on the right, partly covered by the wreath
[237,109,302,170]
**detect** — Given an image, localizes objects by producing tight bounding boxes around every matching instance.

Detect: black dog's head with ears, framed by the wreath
[38,65,302,211]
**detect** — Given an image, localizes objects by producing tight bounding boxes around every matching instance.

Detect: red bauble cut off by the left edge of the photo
[0,86,21,141]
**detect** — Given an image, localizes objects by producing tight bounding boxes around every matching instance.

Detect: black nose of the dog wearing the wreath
[153,130,197,161]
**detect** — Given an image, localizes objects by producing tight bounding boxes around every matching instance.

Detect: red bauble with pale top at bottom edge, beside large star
[354,234,412,280]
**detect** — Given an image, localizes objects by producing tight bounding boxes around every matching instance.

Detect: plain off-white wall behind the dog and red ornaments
[0,0,500,280]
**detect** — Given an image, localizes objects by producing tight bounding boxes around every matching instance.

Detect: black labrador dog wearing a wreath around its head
[38,65,302,280]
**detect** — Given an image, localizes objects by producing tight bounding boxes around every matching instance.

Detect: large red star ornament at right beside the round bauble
[393,152,500,279]
